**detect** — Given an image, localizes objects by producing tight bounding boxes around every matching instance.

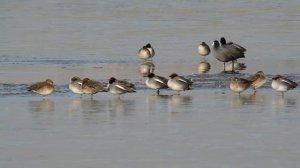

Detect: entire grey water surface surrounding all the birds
[0,0,300,168]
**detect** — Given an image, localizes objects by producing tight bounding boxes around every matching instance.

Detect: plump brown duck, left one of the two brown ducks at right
[229,77,252,95]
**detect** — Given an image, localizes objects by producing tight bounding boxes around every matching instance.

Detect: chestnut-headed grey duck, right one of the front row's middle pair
[168,73,193,94]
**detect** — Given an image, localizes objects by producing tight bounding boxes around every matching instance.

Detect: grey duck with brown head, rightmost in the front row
[271,75,298,96]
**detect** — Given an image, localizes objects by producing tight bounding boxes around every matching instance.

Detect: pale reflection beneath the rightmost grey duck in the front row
[272,96,297,111]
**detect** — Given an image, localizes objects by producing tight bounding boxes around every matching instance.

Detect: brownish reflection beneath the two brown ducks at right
[230,94,265,108]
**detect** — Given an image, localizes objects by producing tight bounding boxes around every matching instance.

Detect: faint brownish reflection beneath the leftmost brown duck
[29,99,55,112]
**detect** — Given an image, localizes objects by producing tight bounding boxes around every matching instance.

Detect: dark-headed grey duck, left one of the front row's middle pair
[145,73,168,95]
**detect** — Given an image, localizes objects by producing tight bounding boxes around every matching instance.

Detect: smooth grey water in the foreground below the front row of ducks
[0,89,300,167]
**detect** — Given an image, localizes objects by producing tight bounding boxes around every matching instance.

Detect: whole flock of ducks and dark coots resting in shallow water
[28,37,297,98]
